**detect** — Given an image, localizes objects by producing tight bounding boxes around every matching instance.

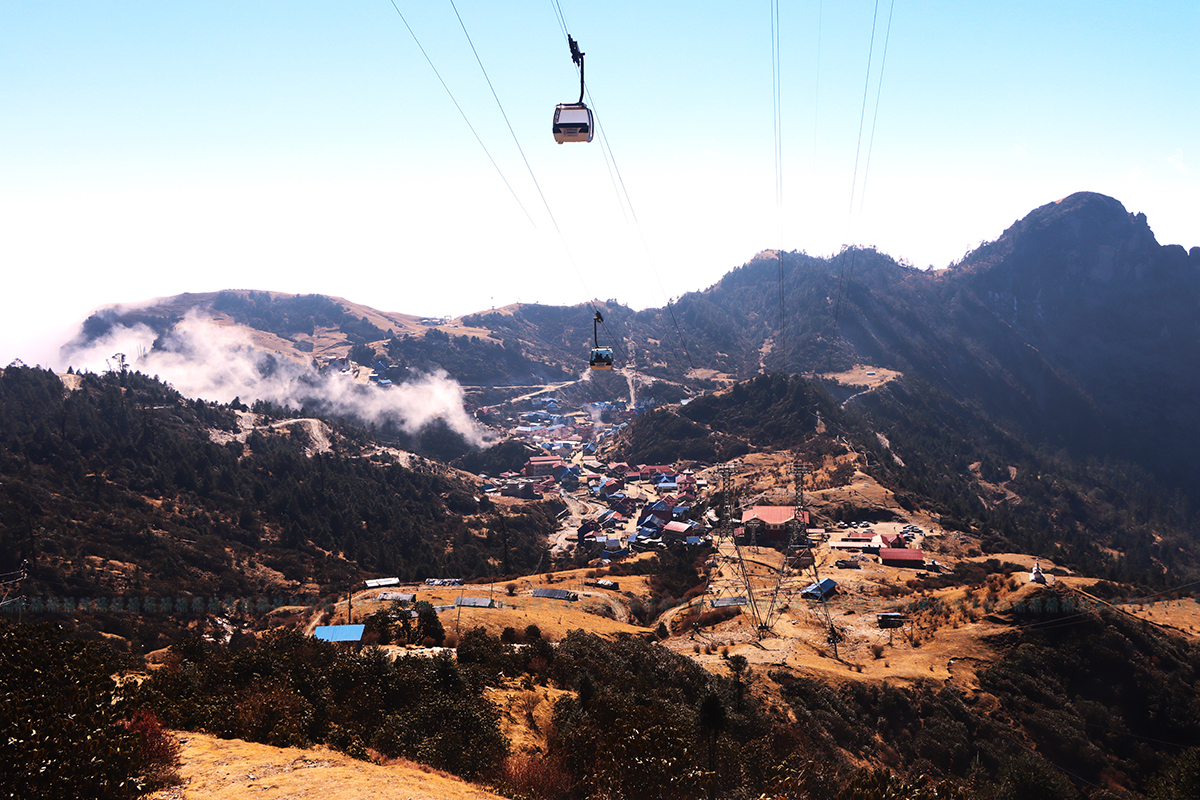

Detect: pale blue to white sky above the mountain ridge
[0,0,1200,368]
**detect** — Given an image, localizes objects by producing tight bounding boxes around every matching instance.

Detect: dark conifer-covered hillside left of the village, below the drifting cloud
[0,367,553,628]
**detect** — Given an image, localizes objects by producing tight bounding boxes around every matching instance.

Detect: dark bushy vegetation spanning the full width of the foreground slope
[9,597,1200,800]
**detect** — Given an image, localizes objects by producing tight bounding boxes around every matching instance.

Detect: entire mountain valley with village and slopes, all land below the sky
[7,193,1200,800]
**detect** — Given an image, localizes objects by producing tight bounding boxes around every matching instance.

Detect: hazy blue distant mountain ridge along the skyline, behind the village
[60,192,1200,506]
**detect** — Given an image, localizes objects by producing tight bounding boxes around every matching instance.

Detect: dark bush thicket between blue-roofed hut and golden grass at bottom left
[137,631,508,778]
